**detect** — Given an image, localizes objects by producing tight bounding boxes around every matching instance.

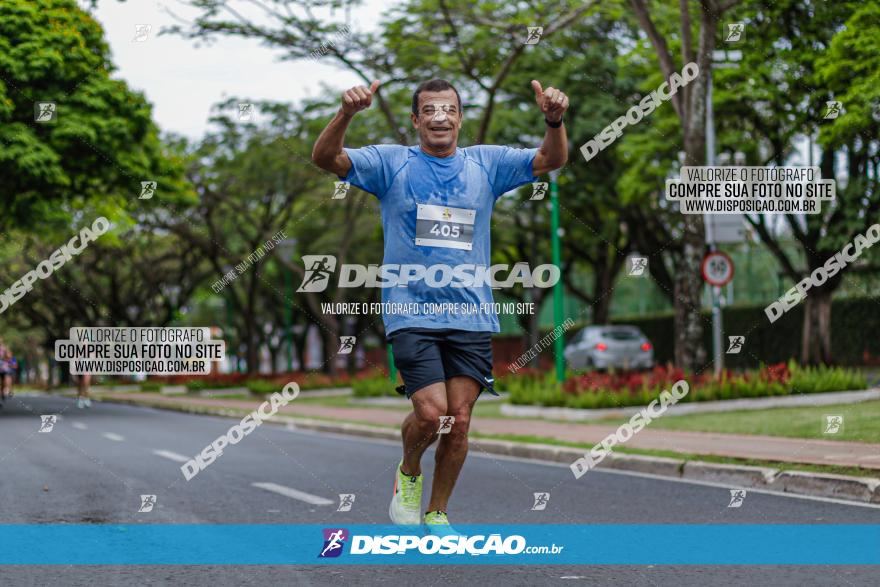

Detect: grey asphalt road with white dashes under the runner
[0,395,880,586]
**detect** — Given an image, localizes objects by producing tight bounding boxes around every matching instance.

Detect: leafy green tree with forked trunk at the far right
[717,1,880,363]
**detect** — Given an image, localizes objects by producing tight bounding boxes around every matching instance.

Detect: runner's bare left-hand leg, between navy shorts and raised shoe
[401,381,446,475]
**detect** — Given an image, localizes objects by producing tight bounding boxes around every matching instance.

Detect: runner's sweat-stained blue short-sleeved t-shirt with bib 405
[341,145,538,334]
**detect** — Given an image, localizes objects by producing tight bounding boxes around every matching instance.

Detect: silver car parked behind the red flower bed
[565,325,654,369]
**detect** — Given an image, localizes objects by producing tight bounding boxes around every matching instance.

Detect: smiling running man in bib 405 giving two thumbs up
[312,79,568,535]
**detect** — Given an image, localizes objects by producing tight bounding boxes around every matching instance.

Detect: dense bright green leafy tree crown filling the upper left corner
[0,0,186,231]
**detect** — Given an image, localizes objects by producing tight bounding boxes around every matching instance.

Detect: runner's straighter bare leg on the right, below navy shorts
[428,377,480,512]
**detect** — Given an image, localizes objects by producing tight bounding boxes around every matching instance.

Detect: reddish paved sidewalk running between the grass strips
[101,393,880,470]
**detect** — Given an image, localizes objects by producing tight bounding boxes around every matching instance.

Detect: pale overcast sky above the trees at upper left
[80,0,393,139]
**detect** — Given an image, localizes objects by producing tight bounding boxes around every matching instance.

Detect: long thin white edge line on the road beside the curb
[274,429,880,509]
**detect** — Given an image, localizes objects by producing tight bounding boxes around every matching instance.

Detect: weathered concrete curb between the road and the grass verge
[103,398,880,504]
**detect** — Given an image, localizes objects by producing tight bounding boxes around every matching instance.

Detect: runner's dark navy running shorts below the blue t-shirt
[388,328,498,399]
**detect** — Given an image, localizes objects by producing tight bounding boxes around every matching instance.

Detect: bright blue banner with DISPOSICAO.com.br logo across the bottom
[0,524,880,565]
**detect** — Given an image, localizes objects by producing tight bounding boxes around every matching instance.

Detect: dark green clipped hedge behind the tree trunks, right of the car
[613,298,880,369]
